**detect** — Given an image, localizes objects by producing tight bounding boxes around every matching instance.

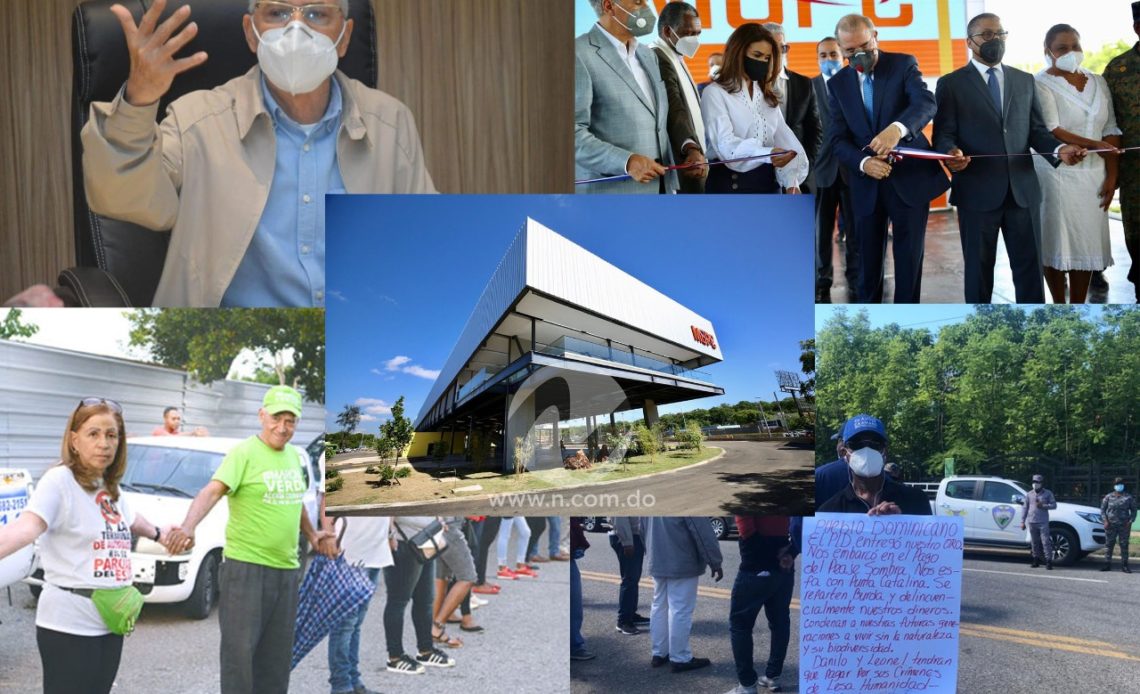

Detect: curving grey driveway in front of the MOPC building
[332,441,815,515]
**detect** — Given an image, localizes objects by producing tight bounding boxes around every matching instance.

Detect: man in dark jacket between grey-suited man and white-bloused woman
[653,2,708,194]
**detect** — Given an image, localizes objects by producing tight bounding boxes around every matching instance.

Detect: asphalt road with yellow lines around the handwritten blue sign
[579,524,1140,694]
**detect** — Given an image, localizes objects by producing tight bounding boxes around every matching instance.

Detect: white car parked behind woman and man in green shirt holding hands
[27,436,324,619]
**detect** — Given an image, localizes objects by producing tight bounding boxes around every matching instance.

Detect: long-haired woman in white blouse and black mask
[701,23,807,193]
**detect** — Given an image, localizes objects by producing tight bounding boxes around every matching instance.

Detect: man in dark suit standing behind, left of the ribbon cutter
[812,36,858,303]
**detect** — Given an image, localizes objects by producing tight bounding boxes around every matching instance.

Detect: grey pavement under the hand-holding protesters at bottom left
[0,524,570,694]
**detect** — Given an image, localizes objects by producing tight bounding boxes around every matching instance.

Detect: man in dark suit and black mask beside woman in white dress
[934,13,1085,303]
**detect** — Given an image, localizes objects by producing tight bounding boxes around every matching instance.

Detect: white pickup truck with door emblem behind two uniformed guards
[907,475,1105,566]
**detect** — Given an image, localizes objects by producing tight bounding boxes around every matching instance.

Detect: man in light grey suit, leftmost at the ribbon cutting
[573,0,678,193]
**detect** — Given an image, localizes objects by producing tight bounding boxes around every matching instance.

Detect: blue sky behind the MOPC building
[326,195,814,432]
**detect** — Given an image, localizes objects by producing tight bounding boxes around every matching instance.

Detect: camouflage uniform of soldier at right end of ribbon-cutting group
[1105,41,1140,300]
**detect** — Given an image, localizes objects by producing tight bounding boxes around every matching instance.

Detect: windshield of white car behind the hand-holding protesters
[122,446,223,498]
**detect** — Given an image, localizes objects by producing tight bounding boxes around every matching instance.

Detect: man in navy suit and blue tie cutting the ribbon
[828,15,950,303]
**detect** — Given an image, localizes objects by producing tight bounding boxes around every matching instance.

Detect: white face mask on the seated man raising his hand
[253,21,348,96]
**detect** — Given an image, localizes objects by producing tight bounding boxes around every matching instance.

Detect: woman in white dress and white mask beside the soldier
[1033,24,1121,303]
